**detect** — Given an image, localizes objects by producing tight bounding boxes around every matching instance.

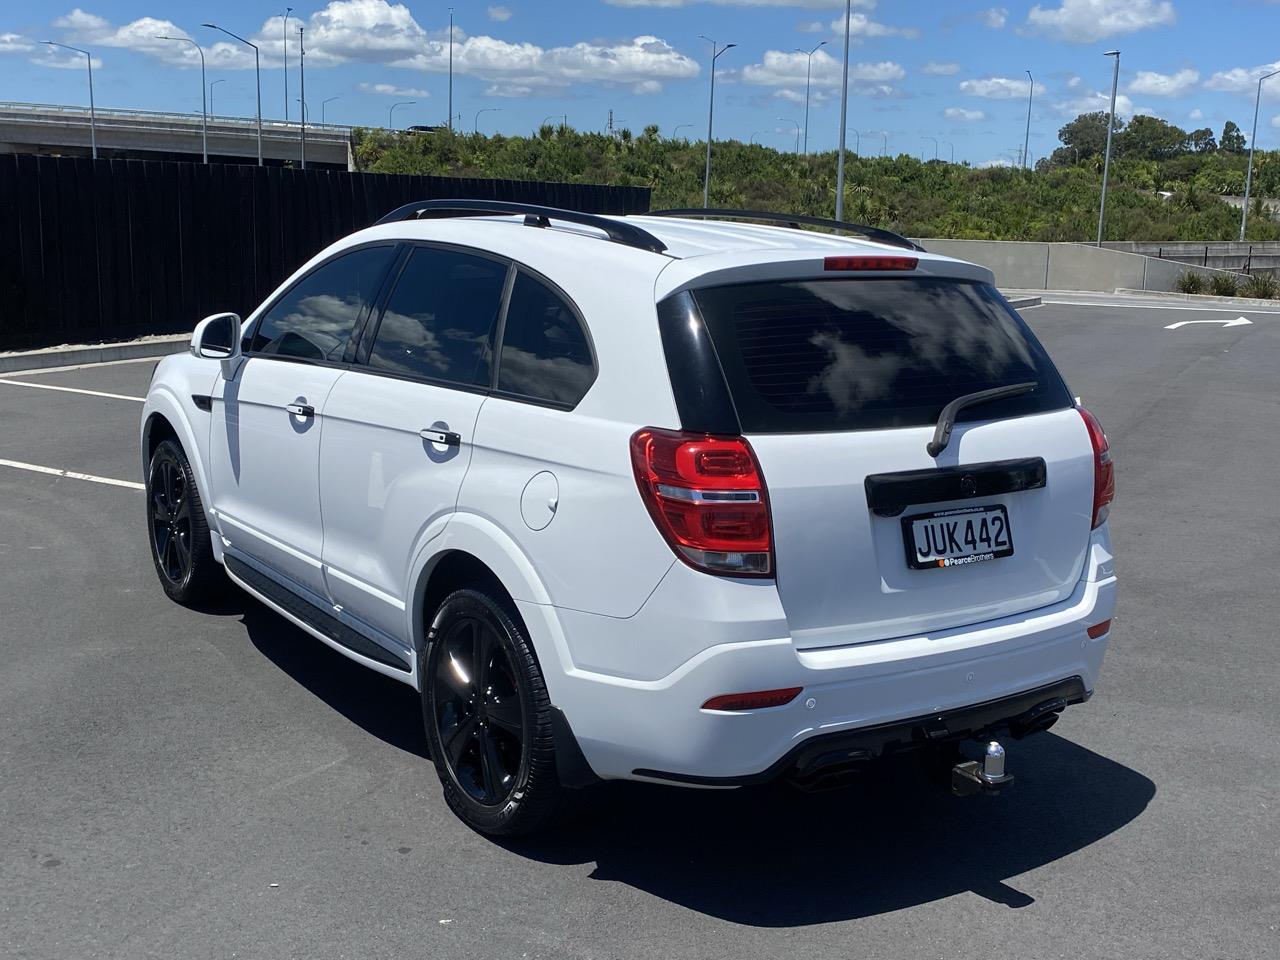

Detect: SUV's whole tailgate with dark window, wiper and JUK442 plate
[694,274,1093,648]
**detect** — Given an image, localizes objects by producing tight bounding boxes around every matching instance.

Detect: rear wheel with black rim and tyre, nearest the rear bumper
[422,588,563,837]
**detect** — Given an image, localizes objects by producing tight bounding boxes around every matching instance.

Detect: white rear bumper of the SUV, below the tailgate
[531,550,1116,787]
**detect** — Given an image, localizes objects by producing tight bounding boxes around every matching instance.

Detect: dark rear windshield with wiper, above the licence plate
[694,278,1071,433]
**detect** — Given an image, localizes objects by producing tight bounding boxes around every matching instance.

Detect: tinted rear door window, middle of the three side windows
[369,247,507,387]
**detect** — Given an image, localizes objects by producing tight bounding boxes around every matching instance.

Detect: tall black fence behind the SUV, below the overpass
[0,154,649,351]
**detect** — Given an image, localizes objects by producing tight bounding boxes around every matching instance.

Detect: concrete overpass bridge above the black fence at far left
[0,101,355,170]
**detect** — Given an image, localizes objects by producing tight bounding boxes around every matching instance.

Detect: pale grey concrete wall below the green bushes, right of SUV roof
[920,239,1219,293]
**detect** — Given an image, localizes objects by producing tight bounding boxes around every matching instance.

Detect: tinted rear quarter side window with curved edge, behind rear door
[498,273,595,407]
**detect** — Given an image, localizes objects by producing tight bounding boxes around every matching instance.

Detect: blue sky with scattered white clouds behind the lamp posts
[0,0,1280,164]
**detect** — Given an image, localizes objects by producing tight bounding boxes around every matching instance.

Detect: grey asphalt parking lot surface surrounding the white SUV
[0,296,1280,960]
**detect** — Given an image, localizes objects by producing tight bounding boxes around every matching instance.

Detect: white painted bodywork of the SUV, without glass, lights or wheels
[143,209,1116,777]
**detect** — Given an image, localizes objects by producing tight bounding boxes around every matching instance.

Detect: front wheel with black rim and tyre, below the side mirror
[146,440,225,607]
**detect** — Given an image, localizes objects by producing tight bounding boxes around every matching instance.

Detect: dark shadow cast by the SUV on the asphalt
[219,598,1156,927]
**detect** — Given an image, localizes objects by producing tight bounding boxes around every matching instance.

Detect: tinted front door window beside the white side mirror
[244,247,394,361]
